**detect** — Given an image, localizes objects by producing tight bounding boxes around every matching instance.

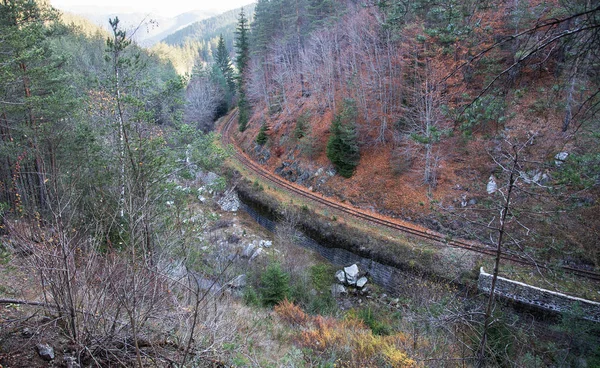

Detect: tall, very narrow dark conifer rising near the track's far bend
[235,8,250,132]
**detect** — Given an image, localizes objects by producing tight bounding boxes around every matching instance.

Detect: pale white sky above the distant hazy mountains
[50,0,253,17]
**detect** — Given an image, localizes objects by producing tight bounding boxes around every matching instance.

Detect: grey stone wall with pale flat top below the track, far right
[477,267,600,322]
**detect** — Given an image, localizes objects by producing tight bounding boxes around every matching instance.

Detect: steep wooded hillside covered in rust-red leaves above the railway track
[232,1,600,268]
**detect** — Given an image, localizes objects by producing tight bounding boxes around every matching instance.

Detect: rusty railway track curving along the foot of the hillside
[221,110,600,281]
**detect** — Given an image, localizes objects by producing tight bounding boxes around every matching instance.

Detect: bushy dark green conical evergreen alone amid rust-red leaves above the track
[327,99,360,178]
